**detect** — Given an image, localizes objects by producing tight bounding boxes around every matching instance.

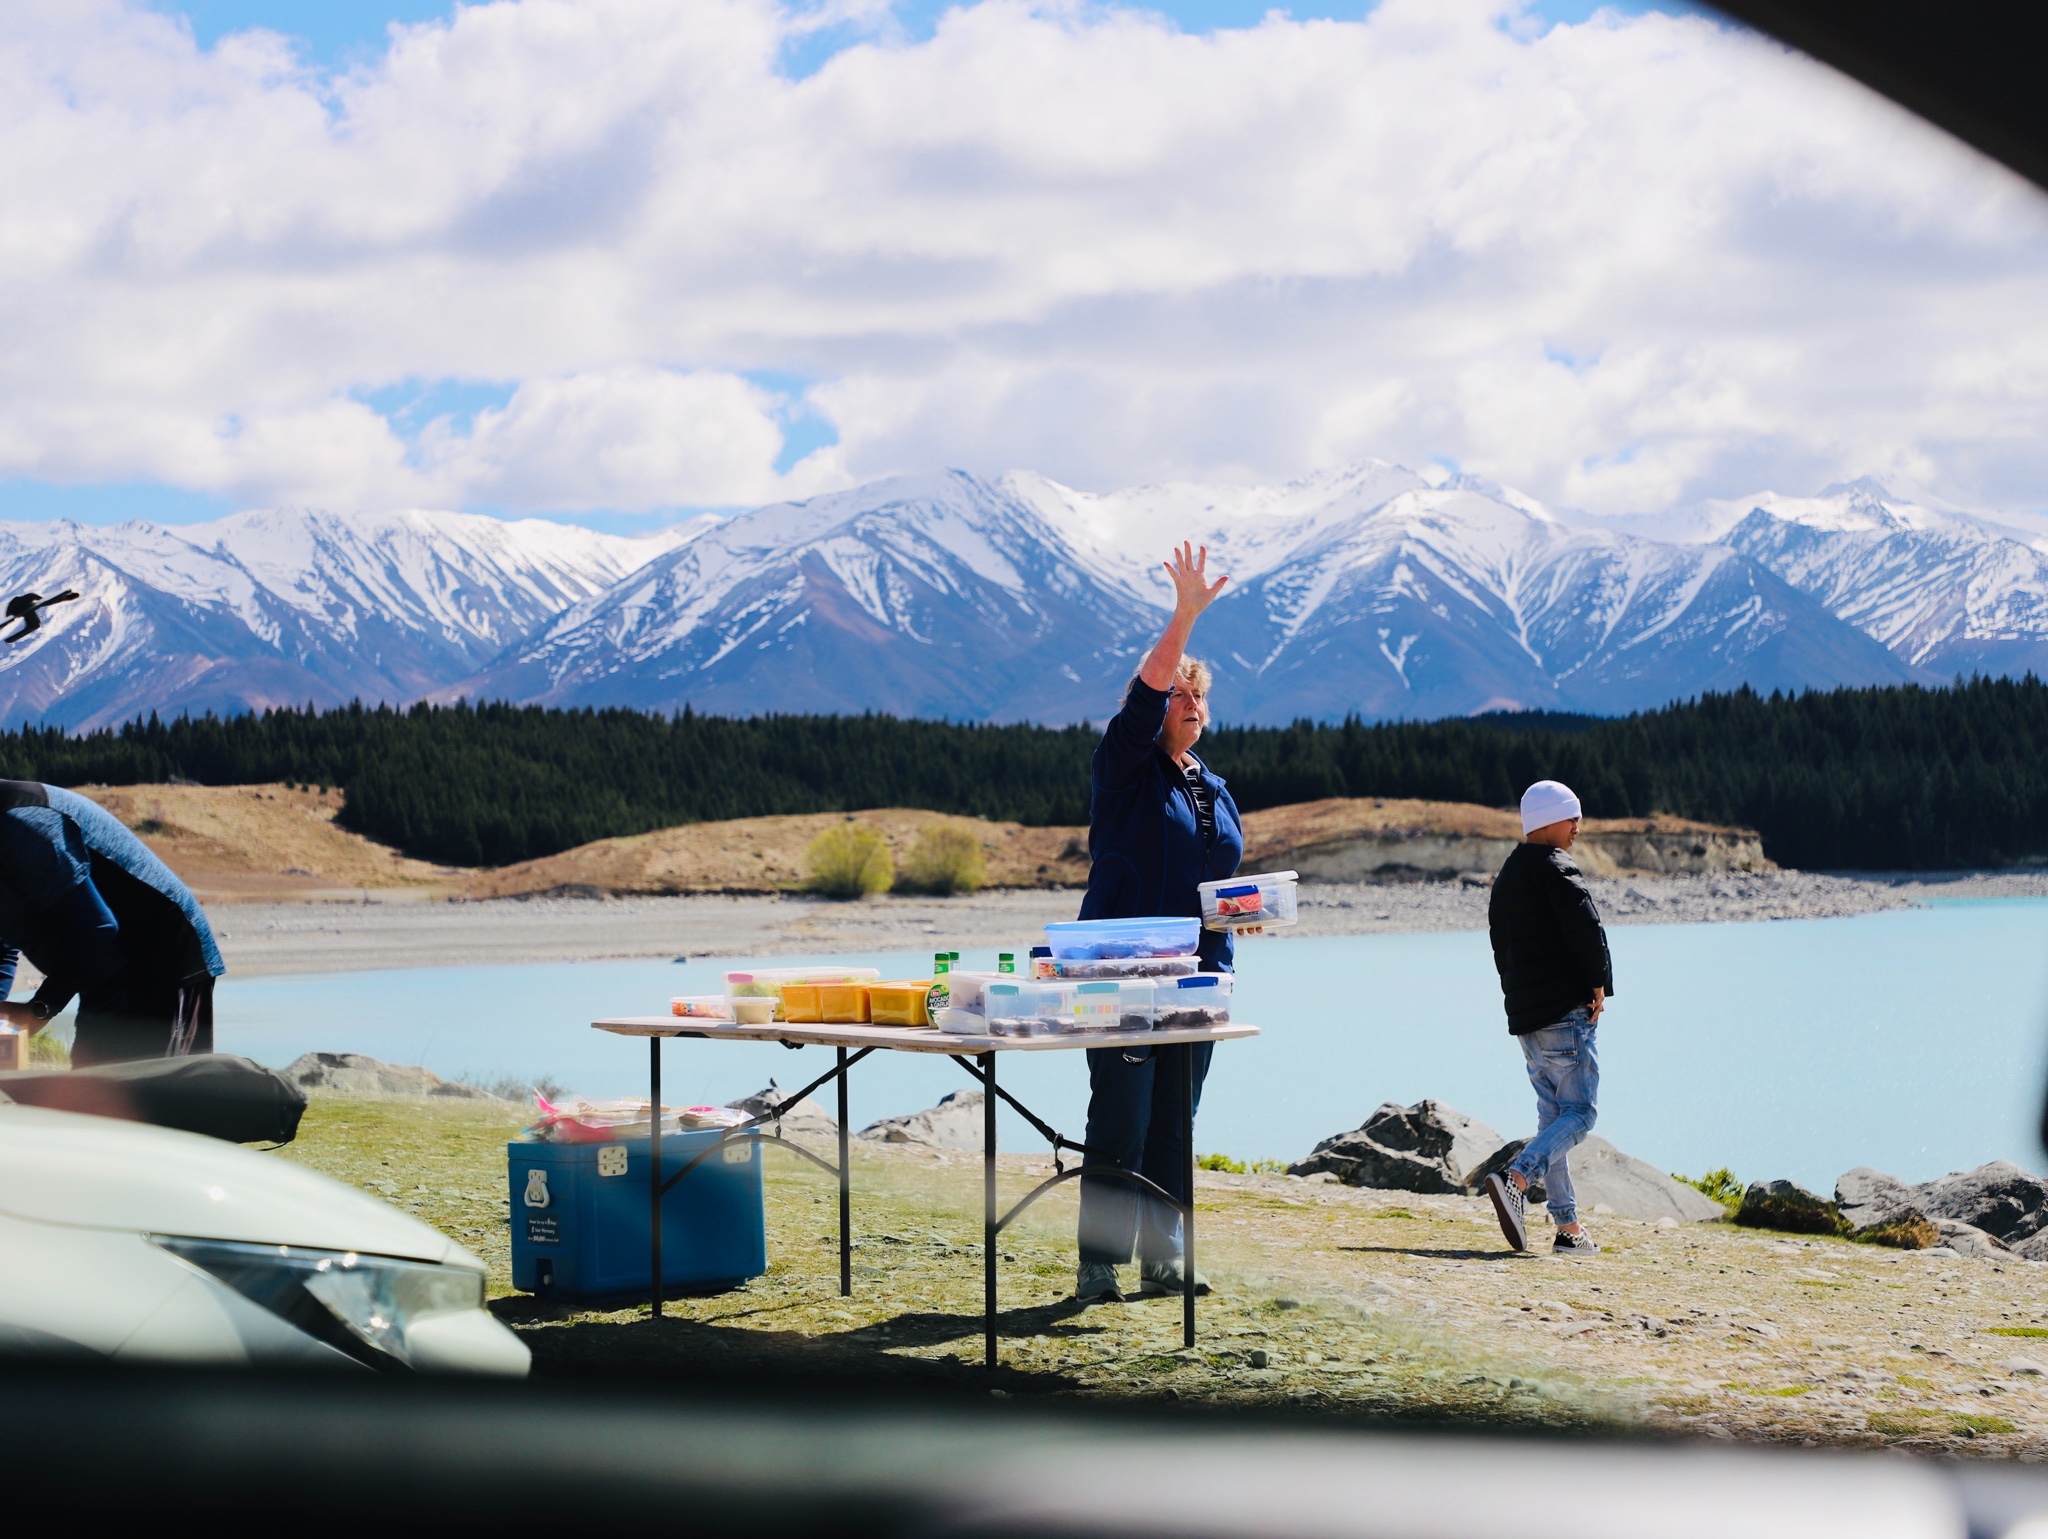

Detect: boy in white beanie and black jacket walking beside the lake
[1485,781,1614,1256]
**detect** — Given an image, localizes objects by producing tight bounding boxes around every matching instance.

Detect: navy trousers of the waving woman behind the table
[1081,1041,1217,1266]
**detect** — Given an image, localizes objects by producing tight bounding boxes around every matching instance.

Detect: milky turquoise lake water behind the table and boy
[203,900,2048,1191]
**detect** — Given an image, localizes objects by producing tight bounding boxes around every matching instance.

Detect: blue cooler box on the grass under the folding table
[506,1129,768,1299]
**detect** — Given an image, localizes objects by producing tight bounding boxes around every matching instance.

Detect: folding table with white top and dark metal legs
[590,1014,1260,1367]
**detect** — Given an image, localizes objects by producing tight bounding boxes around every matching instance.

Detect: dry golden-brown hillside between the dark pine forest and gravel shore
[64,785,1769,902]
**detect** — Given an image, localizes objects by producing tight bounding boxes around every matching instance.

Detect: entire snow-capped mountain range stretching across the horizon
[0,461,2048,730]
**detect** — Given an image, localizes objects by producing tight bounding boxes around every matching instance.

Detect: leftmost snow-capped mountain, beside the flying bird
[0,510,700,730]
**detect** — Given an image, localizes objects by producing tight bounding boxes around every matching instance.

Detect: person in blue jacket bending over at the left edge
[0,781,227,1068]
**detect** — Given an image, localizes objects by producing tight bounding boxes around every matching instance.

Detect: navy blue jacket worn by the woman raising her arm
[1081,678,1245,971]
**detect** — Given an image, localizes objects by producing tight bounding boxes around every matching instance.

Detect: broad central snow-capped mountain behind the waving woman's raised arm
[456,463,1923,721]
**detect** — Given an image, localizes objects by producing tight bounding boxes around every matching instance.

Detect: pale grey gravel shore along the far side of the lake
[213,871,2048,975]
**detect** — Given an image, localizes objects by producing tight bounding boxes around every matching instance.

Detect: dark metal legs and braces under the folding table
[647,1037,1196,1369]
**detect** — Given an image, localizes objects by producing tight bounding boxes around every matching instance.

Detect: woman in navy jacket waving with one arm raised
[1073,545,1245,1301]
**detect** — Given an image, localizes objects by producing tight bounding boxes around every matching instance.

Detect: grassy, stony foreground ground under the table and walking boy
[281,1098,2048,1459]
